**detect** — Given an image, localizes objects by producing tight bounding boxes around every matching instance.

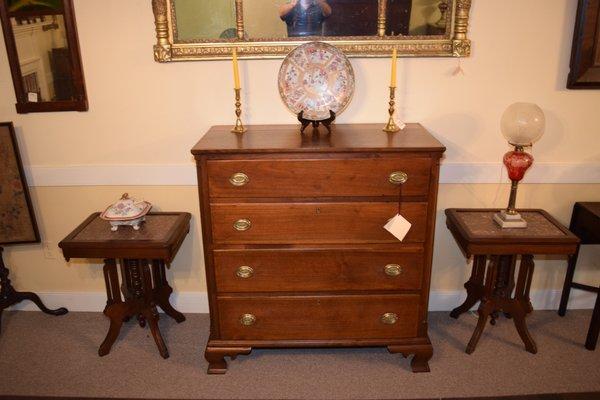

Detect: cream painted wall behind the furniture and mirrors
[0,0,600,306]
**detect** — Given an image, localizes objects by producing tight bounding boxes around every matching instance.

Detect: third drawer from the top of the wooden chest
[214,249,423,293]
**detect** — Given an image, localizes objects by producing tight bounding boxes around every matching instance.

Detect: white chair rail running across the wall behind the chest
[25,162,600,186]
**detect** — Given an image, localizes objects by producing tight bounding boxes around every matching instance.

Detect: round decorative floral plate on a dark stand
[279,42,354,121]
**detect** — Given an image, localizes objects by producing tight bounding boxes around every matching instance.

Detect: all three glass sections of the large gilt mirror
[175,0,450,41]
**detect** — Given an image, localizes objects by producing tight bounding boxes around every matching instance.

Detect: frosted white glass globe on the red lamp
[500,103,546,146]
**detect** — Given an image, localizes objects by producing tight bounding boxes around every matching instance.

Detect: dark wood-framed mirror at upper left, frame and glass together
[0,0,88,114]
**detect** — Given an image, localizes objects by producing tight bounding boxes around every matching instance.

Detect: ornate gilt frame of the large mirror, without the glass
[151,0,471,62]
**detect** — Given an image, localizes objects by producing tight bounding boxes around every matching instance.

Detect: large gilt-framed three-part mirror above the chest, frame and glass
[152,0,471,62]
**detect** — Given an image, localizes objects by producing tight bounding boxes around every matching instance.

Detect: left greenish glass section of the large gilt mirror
[174,0,236,42]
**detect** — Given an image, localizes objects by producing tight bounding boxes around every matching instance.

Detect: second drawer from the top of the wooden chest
[211,202,427,244]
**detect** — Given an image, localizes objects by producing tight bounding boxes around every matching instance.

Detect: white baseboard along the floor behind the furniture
[7,290,596,314]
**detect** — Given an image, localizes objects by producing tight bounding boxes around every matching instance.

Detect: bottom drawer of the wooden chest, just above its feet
[218,294,420,340]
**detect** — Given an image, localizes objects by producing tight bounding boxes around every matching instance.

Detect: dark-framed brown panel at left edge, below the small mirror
[0,122,40,245]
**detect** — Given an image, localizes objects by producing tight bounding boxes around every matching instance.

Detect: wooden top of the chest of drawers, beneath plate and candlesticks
[192,124,446,155]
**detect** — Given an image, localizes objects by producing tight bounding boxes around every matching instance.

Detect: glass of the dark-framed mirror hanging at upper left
[8,0,76,103]
